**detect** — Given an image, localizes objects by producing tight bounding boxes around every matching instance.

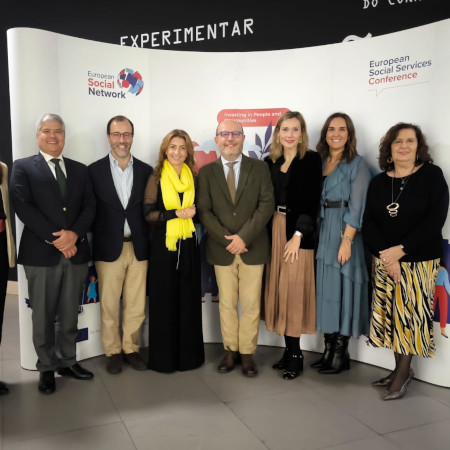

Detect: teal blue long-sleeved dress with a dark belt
[316,155,371,338]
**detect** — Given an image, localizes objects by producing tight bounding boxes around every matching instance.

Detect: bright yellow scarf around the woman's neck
[160,159,195,251]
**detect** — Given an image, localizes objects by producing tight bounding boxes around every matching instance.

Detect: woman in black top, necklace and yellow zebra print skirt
[363,122,449,400]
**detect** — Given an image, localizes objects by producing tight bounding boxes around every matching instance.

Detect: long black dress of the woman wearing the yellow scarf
[144,175,205,372]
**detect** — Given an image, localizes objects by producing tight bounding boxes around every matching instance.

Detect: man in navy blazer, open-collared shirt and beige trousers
[89,116,152,374]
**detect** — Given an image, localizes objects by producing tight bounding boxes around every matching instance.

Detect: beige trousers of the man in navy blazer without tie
[95,242,148,356]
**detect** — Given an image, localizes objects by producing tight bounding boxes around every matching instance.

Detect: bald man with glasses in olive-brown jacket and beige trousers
[197,120,275,377]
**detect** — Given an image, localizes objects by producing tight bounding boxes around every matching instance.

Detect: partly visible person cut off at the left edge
[0,157,16,395]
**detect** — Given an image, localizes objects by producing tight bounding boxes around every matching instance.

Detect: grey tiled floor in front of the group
[0,295,450,450]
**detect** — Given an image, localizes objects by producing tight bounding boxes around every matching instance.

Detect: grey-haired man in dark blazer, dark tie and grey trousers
[10,114,95,394]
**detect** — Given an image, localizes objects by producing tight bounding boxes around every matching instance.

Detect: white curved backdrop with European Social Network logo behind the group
[8,20,450,387]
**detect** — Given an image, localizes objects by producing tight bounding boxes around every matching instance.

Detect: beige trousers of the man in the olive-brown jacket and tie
[214,255,264,354]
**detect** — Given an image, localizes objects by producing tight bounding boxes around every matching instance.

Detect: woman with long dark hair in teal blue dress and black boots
[312,112,371,374]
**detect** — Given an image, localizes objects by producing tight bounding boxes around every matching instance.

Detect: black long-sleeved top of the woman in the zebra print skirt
[363,163,449,262]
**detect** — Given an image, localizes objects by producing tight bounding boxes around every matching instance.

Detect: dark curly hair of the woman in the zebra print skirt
[378,122,433,172]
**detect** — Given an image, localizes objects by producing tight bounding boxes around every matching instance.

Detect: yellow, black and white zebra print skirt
[368,257,439,358]
